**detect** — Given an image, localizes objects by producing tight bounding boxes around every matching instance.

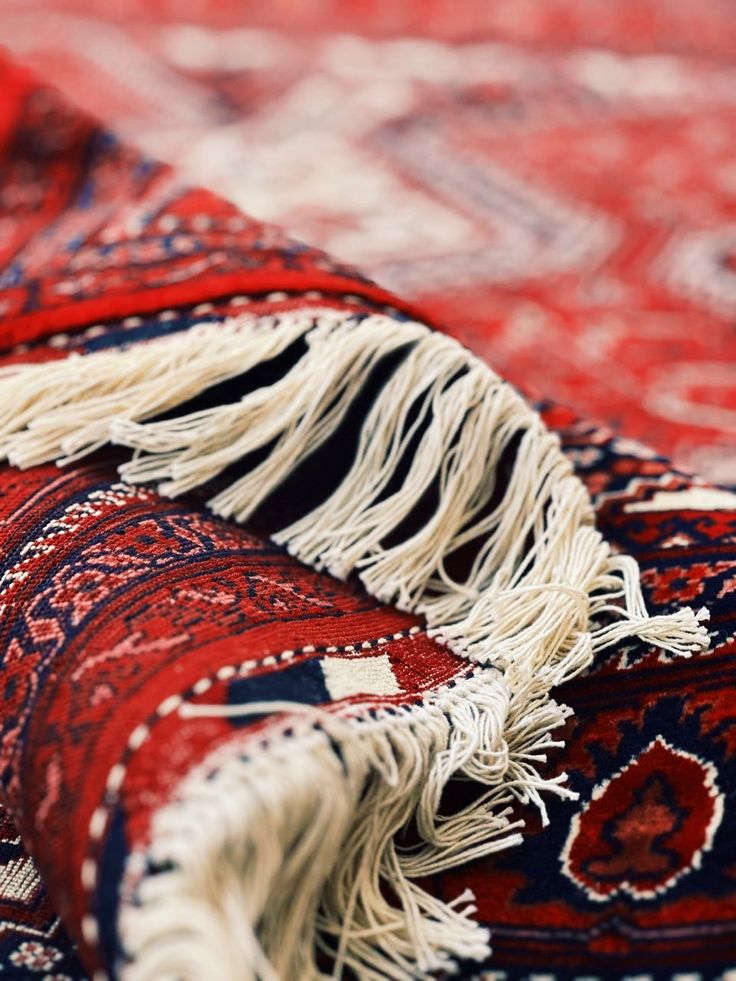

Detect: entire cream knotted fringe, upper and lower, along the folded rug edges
[0,311,708,979]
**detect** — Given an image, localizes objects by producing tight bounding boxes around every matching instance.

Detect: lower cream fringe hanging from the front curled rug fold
[120,688,521,981]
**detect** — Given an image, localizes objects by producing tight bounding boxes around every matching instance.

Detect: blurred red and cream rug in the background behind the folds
[0,0,736,483]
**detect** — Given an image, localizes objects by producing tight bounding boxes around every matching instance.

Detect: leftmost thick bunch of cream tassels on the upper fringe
[0,314,324,468]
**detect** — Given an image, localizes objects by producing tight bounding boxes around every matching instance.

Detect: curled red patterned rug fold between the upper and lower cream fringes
[0,461,472,976]
